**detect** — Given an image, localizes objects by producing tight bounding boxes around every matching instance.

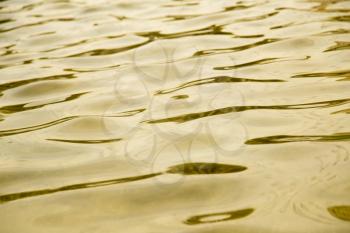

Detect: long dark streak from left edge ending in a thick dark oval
[0,163,247,204]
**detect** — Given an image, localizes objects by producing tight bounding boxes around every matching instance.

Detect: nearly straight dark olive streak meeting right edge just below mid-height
[245,133,350,145]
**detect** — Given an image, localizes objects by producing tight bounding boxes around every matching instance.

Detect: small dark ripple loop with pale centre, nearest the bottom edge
[184,208,254,225]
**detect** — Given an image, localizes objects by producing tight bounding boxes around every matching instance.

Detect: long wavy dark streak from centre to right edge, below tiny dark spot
[144,99,350,124]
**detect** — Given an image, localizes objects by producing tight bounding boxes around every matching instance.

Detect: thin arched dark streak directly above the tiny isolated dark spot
[155,76,284,95]
